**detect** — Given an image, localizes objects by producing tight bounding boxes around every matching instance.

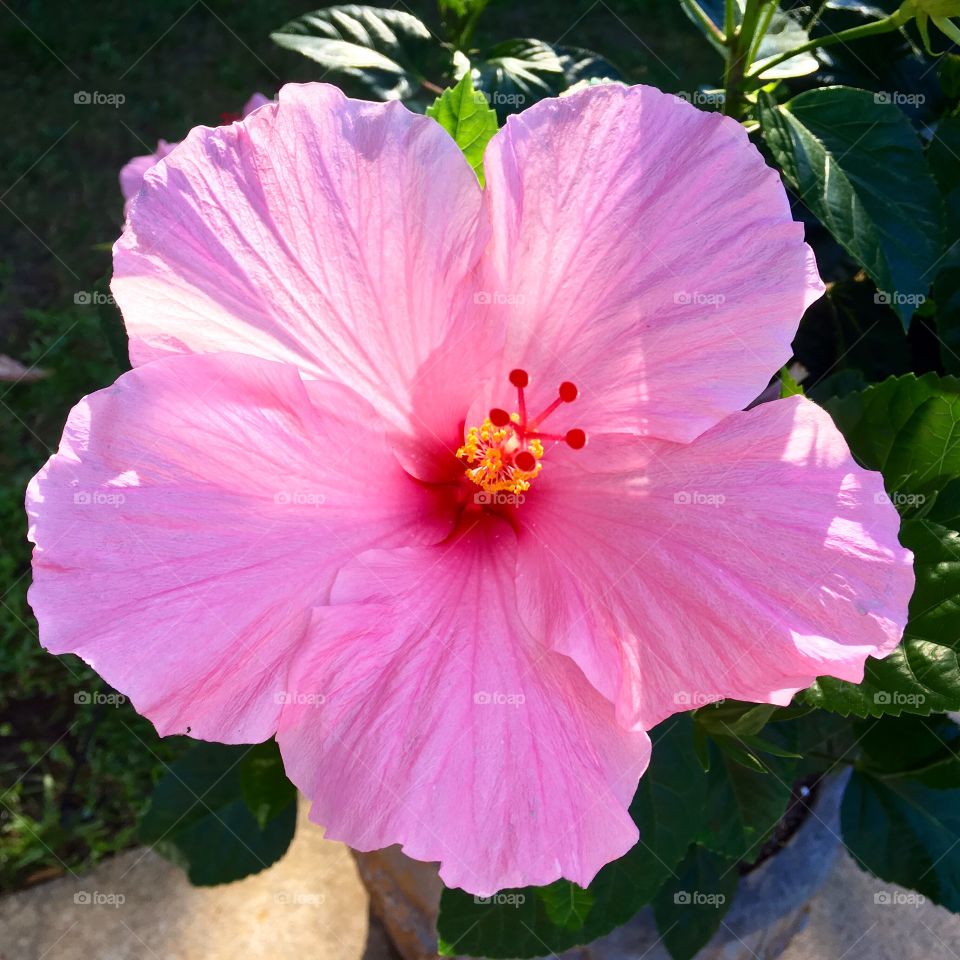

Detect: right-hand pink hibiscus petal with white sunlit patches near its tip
[518,397,914,729]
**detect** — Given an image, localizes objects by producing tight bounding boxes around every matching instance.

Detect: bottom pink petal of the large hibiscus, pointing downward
[277,521,650,896]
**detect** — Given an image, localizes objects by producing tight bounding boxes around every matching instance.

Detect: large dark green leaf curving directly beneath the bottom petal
[437,716,706,958]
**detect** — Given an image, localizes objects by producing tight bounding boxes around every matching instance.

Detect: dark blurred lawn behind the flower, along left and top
[0,0,719,891]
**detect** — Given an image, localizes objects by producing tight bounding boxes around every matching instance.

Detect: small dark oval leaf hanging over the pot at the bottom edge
[653,845,740,960]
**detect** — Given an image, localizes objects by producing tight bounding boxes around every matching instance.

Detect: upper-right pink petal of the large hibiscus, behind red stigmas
[484,84,823,441]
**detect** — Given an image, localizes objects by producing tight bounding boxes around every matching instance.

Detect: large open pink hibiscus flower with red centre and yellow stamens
[28,84,913,894]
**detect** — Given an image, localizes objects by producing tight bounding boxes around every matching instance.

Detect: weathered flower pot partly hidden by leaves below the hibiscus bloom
[354,775,847,960]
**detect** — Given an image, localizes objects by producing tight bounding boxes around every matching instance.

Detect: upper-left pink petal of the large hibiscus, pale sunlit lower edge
[112,84,487,425]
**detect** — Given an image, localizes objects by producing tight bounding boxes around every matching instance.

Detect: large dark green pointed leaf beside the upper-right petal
[758,87,943,329]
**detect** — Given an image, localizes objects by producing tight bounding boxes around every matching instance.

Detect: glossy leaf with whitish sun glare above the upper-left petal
[270,4,453,100]
